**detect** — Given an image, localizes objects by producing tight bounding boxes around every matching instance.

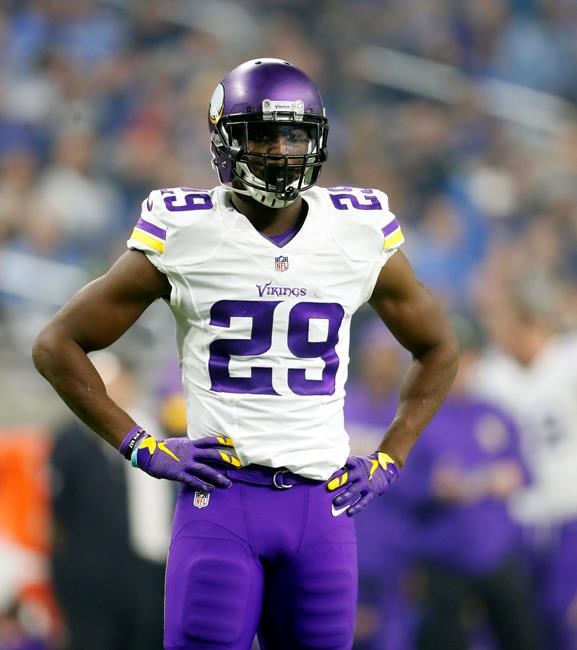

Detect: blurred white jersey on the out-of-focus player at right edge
[472,335,577,525]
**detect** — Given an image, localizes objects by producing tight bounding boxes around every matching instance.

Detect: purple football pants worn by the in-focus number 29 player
[164,467,357,650]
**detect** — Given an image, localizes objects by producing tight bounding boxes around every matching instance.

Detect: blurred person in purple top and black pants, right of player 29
[397,321,540,650]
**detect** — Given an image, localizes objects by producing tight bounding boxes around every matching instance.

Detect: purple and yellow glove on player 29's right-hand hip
[327,451,399,517]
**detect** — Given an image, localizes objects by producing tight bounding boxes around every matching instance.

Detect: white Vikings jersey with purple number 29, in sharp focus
[128,187,403,480]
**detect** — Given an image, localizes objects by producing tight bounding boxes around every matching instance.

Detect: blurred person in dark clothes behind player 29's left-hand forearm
[50,351,178,650]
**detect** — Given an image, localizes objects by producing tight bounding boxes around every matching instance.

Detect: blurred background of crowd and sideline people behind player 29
[0,0,577,650]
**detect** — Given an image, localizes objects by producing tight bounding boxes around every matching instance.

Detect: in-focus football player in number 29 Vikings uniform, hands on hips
[33,59,457,650]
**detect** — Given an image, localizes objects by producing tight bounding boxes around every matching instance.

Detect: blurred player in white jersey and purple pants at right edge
[472,286,577,650]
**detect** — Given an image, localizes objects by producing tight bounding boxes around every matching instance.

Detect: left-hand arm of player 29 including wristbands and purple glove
[33,251,239,492]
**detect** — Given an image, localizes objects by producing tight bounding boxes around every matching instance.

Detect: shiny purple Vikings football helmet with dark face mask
[208,59,328,208]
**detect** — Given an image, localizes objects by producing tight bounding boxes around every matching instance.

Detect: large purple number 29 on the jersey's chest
[208,300,345,395]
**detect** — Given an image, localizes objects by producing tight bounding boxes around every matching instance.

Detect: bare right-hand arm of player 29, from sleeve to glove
[369,251,459,466]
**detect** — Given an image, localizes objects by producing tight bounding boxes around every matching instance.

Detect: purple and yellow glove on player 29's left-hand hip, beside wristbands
[120,430,241,492]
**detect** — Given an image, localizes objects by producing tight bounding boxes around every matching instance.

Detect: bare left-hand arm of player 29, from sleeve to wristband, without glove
[33,251,170,447]
